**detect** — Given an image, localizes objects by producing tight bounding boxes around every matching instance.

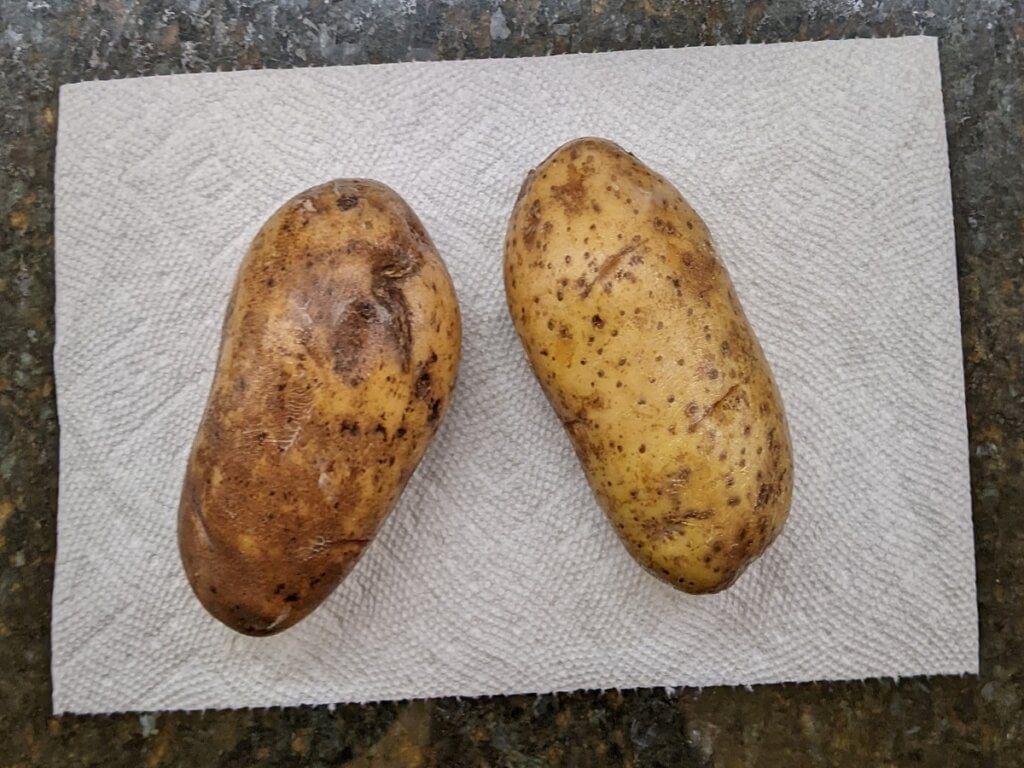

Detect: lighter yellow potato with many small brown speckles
[505,138,793,593]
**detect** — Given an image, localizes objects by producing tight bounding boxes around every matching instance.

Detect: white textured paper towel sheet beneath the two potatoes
[52,38,977,712]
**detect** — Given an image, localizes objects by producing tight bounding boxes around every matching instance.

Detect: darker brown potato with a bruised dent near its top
[178,179,461,635]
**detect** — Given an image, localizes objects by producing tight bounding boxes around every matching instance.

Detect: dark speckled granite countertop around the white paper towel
[0,0,1024,768]
